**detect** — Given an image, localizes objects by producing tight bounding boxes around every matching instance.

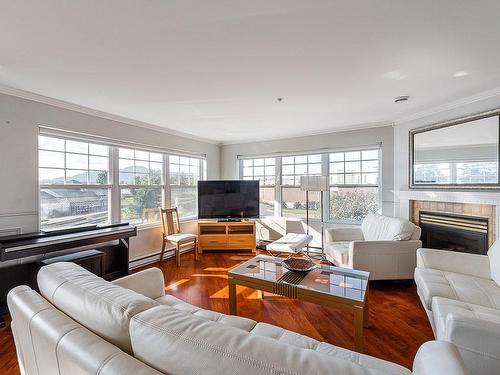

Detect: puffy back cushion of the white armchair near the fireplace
[361,214,418,241]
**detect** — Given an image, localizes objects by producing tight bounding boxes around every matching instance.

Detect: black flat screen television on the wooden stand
[198,180,259,219]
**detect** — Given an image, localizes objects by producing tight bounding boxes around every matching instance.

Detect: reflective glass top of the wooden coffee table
[229,255,370,301]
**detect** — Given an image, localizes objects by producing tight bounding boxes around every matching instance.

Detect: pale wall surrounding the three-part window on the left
[0,94,220,258]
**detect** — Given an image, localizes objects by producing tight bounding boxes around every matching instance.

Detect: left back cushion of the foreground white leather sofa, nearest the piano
[38,262,159,353]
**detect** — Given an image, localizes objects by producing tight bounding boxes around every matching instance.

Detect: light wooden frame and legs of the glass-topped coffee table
[228,264,369,353]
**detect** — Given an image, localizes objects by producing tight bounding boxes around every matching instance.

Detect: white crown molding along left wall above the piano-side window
[0,84,220,146]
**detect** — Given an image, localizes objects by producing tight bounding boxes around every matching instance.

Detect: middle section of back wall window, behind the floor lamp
[281,154,321,218]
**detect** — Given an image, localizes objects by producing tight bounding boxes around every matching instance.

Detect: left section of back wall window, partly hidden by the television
[242,158,276,216]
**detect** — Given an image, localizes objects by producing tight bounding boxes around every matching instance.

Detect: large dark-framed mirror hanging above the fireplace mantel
[410,110,500,189]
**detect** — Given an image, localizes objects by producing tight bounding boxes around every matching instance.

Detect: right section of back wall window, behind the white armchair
[329,149,379,222]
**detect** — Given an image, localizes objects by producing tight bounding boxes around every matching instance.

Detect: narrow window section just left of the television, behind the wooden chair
[168,155,204,219]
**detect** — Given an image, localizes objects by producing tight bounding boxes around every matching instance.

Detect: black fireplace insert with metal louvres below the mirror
[419,211,488,255]
